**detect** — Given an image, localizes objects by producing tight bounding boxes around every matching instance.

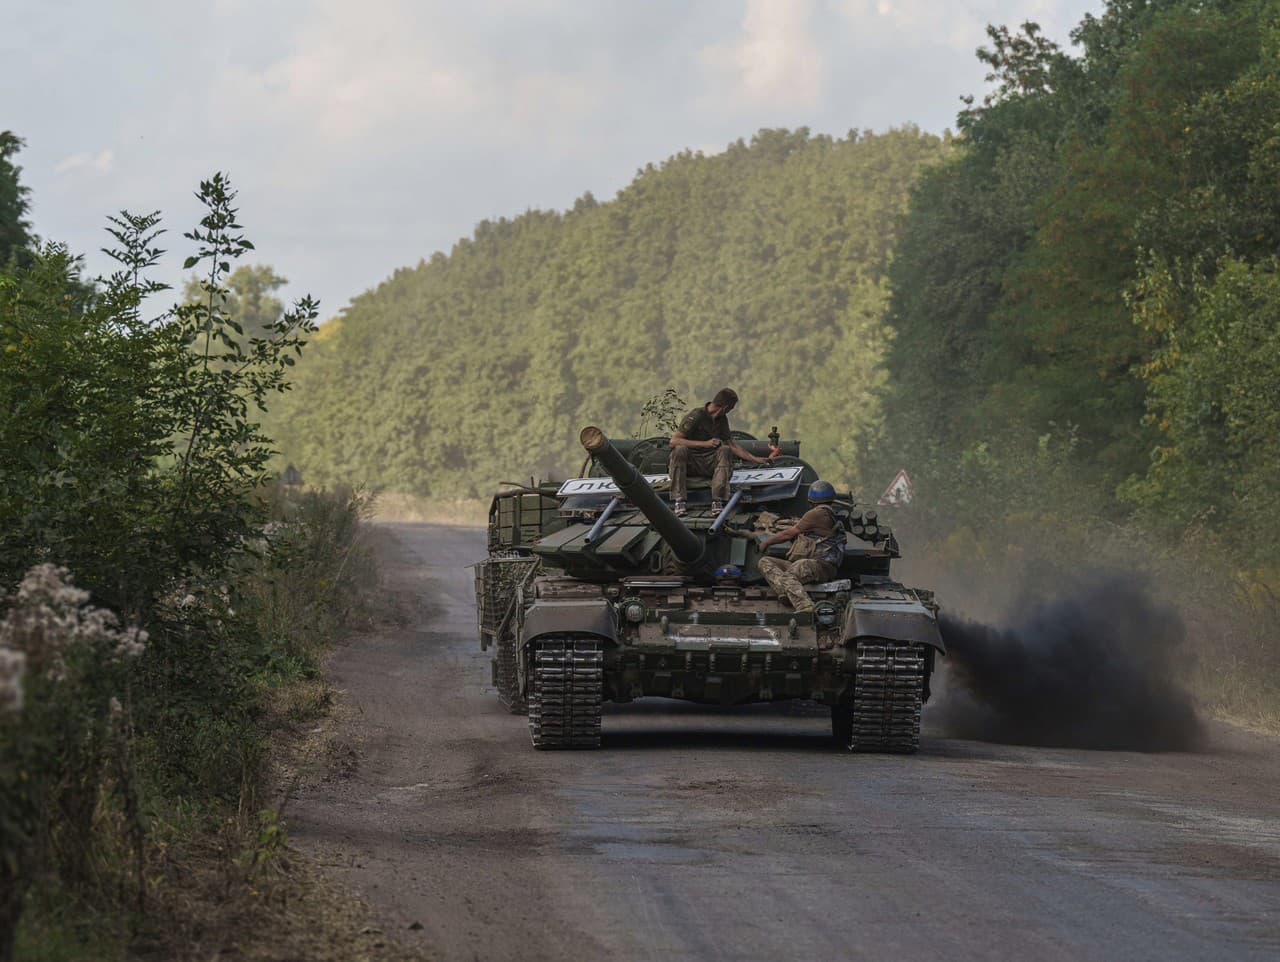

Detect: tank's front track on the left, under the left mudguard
[529,637,604,748]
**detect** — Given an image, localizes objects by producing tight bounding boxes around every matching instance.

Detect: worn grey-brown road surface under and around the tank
[289,524,1280,962]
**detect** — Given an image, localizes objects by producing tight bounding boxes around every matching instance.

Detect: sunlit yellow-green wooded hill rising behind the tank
[270,128,951,495]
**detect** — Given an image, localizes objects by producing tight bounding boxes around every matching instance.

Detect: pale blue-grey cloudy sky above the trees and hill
[0,0,1102,317]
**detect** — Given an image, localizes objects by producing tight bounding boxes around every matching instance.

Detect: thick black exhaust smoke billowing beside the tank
[936,578,1202,751]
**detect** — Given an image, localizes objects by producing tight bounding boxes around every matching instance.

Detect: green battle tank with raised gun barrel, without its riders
[475,426,946,753]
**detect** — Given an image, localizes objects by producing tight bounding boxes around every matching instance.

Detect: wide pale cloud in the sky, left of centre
[207,0,607,148]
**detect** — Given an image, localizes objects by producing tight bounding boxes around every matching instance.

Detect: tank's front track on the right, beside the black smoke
[849,638,924,755]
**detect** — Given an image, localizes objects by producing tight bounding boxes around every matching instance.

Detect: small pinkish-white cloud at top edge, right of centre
[701,0,823,107]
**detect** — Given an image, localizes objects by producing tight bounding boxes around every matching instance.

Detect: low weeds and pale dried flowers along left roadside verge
[3,491,399,962]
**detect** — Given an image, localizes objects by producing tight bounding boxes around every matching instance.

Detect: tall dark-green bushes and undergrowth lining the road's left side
[0,175,384,958]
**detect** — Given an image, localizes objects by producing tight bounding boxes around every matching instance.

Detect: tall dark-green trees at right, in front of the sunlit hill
[882,0,1280,562]
